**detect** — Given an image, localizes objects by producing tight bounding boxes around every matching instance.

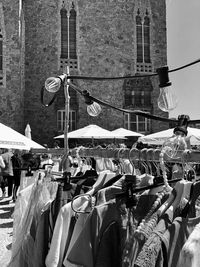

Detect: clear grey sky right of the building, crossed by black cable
[166,0,200,119]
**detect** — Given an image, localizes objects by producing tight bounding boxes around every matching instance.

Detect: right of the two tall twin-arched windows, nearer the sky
[136,10,151,63]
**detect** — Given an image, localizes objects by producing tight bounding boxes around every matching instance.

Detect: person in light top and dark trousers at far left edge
[1,148,13,197]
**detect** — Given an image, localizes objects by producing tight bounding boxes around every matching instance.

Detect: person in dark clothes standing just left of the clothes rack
[11,149,22,202]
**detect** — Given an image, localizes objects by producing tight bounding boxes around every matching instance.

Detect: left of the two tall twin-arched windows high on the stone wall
[60,4,77,59]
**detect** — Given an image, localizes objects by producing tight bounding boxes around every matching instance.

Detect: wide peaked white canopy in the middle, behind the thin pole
[54,124,125,139]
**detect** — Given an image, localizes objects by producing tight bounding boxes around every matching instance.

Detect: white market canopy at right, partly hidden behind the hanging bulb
[138,127,200,146]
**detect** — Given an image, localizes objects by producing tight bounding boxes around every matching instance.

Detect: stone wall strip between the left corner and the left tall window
[25,0,59,147]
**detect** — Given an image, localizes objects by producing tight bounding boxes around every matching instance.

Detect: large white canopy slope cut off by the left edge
[0,123,44,150]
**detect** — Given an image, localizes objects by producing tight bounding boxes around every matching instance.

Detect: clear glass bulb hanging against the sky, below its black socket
[158,86,178,112]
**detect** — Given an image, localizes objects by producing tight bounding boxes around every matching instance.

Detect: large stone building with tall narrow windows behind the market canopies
[0,0,168,146]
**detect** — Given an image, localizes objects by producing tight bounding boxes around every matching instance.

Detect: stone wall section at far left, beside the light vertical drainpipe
[0,0,24,132]
